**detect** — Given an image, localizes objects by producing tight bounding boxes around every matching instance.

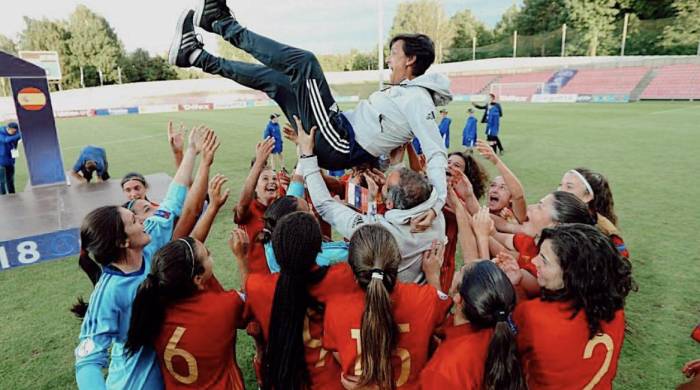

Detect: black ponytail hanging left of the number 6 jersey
[124,274,165,355]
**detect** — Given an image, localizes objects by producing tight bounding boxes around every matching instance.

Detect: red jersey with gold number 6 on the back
[155,276,244,390]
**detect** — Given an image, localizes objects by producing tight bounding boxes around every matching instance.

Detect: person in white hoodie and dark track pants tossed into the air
[169,0,452,228]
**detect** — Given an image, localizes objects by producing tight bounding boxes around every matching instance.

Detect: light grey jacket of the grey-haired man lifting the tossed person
[299,157,446,283]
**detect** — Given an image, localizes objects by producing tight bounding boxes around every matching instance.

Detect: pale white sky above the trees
[0,0,521,54]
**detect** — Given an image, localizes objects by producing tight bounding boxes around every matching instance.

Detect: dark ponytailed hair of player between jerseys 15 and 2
[459,260,527,390]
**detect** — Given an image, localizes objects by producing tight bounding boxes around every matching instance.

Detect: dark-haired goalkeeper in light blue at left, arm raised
[72,139,197,390]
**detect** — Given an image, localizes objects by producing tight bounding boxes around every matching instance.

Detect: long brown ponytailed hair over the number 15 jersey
[348,225,401,389]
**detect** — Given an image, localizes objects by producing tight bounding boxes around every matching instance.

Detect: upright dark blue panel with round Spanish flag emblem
[10,78,66,186]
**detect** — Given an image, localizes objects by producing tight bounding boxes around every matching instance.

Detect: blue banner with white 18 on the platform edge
[0,228,80,271]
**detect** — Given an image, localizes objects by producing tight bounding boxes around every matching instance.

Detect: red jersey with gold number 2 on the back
[513,299,625,390]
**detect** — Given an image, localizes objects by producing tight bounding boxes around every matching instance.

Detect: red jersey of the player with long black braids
[246,263,357,389]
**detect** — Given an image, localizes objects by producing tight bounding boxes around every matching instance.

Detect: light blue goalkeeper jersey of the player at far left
[75,182,187,390]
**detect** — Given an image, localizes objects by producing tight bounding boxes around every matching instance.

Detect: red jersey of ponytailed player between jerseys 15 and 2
[420,323,493,390]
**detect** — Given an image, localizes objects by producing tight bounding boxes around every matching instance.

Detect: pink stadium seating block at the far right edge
[640,64,700,99]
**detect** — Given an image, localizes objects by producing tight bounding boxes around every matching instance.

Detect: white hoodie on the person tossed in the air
[343,73,452,215]
